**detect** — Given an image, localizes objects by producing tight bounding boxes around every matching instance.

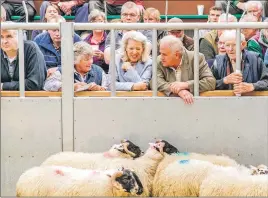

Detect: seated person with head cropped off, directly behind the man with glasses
[90,0,144,15]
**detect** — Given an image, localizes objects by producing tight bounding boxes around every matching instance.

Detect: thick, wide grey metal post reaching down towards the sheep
[60,22,74,151]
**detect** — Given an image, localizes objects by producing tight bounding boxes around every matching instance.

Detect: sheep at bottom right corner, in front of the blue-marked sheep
[199,167,268,197]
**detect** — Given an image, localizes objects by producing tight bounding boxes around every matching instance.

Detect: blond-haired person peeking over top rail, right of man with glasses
[143,8,165,41]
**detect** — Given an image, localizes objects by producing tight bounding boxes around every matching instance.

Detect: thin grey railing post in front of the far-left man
[18,30,25,97]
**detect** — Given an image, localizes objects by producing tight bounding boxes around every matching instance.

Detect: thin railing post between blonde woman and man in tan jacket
[152,29,157,97]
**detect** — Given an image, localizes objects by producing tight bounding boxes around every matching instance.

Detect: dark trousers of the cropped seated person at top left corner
[2,3,36,22]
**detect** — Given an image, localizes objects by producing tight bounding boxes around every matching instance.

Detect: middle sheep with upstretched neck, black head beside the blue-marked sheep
[43,141,178,196]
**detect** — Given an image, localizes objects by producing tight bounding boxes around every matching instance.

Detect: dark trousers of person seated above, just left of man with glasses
[90,0,122,15]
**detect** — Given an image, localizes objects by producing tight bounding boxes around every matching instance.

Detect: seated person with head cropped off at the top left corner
[1,0,36,22]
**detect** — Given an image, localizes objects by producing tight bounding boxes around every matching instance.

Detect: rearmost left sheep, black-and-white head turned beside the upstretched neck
[41,140,142,169]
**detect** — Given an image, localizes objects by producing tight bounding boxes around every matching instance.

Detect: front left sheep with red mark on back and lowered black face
[16,166,143,197]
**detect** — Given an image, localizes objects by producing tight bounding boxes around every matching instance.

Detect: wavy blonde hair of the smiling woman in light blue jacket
[121,31,150,62]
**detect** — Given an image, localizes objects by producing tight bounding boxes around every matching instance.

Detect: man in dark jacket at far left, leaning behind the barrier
[0,25,46,91]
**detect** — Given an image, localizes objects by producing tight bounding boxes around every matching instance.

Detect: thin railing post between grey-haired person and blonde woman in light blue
[110,29,116,97]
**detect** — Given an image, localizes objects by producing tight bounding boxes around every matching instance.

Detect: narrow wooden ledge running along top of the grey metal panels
[1,90,268,97]
